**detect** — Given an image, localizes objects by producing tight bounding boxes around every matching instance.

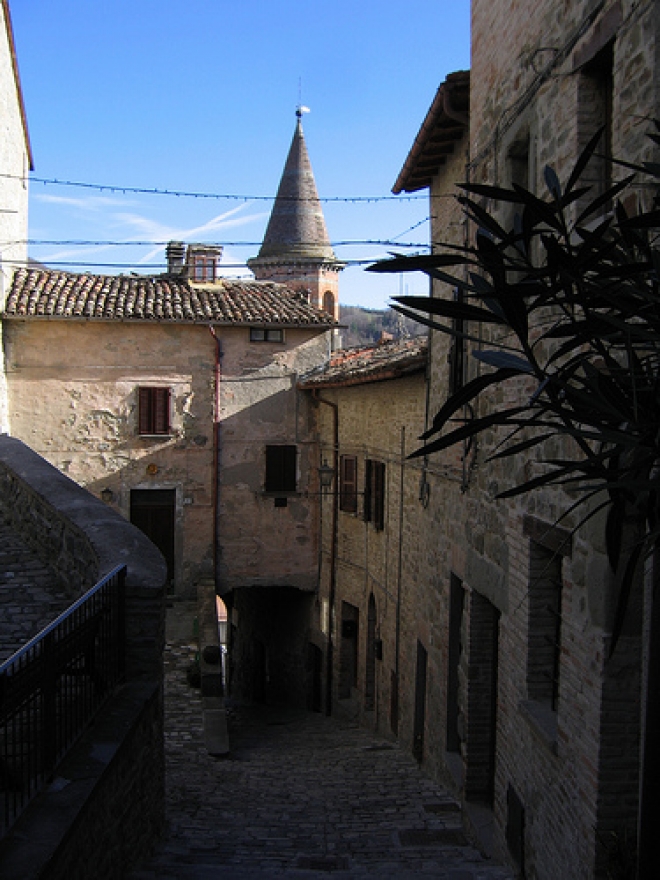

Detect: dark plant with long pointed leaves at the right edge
[369,124,660,644]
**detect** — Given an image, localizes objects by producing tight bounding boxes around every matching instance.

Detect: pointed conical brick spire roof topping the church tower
[250,108,336,262]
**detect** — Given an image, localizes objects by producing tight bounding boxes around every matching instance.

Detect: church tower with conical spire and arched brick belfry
[248,107,345,321]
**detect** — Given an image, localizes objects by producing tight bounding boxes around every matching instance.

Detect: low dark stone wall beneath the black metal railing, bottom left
[0,682,165,880]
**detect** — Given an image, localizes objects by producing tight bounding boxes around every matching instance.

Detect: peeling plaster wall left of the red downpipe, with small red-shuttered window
[4,321,215,595]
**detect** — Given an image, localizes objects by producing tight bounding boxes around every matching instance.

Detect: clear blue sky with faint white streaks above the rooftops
[10,0,470,308]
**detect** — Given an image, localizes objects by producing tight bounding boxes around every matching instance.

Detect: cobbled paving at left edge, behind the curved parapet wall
[0,517,72,663]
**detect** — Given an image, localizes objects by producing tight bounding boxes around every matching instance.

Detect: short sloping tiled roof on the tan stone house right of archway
[299,336,428,388]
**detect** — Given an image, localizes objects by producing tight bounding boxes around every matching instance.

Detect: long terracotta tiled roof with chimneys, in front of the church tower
[3,268,335,329]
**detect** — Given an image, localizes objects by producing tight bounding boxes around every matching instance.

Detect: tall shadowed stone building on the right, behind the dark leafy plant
[386,0,660,880]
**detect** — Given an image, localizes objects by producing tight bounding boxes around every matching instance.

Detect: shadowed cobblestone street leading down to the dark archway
[131,603,512,880]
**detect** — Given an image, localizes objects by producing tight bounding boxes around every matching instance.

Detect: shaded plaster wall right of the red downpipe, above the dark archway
[218,330,329,593]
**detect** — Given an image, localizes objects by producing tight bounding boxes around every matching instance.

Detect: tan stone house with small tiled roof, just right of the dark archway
[300,336,434,720]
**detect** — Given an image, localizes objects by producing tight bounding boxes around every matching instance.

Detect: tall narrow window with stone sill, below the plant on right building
[527,541,562,712]
